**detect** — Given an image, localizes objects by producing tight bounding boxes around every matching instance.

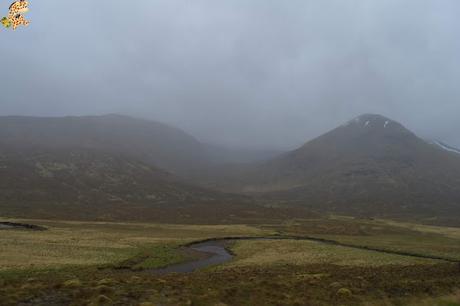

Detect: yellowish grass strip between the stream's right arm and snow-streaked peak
[270,217,460,260]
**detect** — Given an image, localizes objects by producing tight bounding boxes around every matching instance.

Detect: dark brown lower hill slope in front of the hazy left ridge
[0,149,306,224]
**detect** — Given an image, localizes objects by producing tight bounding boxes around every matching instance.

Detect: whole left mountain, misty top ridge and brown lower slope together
[0,115,300,223]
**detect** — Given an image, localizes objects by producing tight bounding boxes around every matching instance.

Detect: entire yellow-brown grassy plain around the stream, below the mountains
[0,217,460,306]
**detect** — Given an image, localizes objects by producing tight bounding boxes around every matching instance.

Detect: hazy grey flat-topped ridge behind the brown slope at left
[0,114,278,176]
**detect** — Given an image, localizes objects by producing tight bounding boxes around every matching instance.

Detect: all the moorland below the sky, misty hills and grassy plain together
[0,115,460,306]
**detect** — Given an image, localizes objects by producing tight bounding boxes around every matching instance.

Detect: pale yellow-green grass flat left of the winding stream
[0,220,268,272]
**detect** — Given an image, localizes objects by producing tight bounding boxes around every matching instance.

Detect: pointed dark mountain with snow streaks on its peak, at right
[208,114,460,215]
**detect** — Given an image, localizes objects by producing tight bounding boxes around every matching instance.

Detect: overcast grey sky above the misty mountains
[0,0,460,148]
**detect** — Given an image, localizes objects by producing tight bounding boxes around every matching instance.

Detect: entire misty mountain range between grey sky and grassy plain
[0,114,460,221]
